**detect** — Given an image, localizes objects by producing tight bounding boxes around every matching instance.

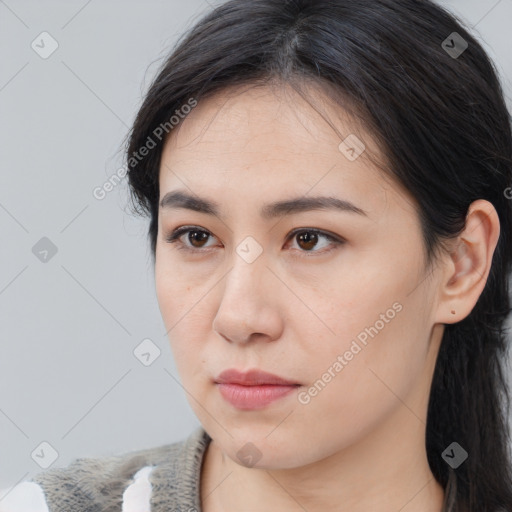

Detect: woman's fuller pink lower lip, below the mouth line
[217,384,297,409]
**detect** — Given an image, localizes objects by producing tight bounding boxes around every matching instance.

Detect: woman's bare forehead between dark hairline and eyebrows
[160,87,414,220]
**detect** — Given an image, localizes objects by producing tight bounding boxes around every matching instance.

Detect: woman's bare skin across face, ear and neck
[155,86,499,512]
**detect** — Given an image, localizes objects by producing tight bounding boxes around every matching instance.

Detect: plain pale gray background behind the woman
[0,0,512,488]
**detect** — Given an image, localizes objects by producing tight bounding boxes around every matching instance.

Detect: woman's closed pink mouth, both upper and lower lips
[215,369,300,410]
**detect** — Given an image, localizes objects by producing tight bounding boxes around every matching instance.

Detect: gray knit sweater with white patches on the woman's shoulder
[0,427,211,512]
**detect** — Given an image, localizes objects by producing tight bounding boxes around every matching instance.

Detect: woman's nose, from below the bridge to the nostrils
[213,253,283,344]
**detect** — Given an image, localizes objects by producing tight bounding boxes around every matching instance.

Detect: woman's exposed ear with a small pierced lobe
[435,199,500,324]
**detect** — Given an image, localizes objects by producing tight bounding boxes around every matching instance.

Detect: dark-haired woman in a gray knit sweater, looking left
[0,0,512,512]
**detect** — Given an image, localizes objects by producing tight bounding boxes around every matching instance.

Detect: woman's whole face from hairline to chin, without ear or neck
[155,83,442,468]
